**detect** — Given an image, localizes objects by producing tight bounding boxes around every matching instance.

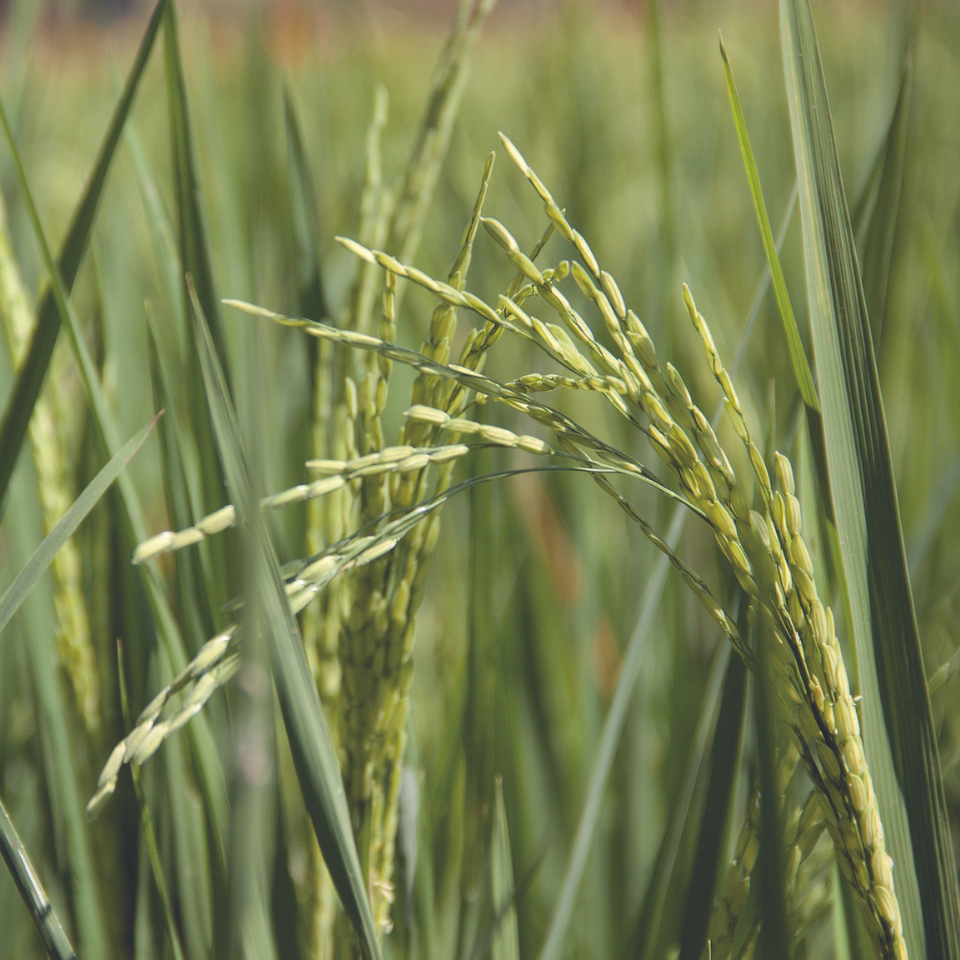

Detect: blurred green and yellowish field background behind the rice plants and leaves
[0,0,960,957]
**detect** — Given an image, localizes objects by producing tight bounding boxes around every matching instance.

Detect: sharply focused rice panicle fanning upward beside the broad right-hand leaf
[320,141,905,957]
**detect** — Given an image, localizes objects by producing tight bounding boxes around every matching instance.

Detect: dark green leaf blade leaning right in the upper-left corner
[0,0,168,504]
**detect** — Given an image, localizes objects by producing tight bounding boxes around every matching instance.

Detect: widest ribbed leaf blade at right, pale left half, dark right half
[780,0,960,960]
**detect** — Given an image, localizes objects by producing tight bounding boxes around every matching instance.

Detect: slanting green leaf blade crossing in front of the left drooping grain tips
[188,290,380,960]
